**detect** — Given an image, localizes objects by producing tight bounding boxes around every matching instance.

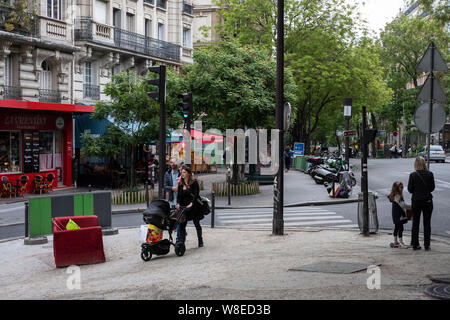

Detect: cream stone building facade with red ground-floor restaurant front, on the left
[0,0,194,191]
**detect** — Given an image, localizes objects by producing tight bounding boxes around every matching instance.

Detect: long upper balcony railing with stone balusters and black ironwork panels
[75,19,180,61]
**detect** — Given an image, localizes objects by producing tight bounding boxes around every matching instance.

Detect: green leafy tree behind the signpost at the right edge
[380,10,450,148]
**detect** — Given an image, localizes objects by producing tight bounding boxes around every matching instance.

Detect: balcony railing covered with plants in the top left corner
[0,5,38,37]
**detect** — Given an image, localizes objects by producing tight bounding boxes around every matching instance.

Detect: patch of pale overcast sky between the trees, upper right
[356,0,405,34]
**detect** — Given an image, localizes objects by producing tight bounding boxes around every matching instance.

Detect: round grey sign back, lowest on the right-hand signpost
[414,103,446,133]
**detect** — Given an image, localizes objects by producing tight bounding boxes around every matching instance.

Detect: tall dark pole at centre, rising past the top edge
[272,0,284,236]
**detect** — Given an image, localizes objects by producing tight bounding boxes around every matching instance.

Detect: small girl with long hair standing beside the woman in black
[388,181,409,248]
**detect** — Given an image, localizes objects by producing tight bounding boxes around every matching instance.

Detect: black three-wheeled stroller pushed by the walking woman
[141,200,186,261]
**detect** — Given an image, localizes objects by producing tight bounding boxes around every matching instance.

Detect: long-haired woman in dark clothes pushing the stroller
[176,165,205,247]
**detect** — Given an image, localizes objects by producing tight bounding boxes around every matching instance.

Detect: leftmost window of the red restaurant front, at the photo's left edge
[0,131,21,173]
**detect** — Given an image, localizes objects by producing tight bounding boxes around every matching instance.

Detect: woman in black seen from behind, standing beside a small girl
[408,156,435,251]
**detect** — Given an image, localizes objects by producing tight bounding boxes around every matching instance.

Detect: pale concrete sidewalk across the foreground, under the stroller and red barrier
[0,227,450,300]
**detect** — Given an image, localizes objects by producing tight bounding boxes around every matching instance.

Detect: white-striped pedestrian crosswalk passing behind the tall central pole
[216,207,358,228]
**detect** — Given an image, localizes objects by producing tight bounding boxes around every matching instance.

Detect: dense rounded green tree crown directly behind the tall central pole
[180,40,295,130]
